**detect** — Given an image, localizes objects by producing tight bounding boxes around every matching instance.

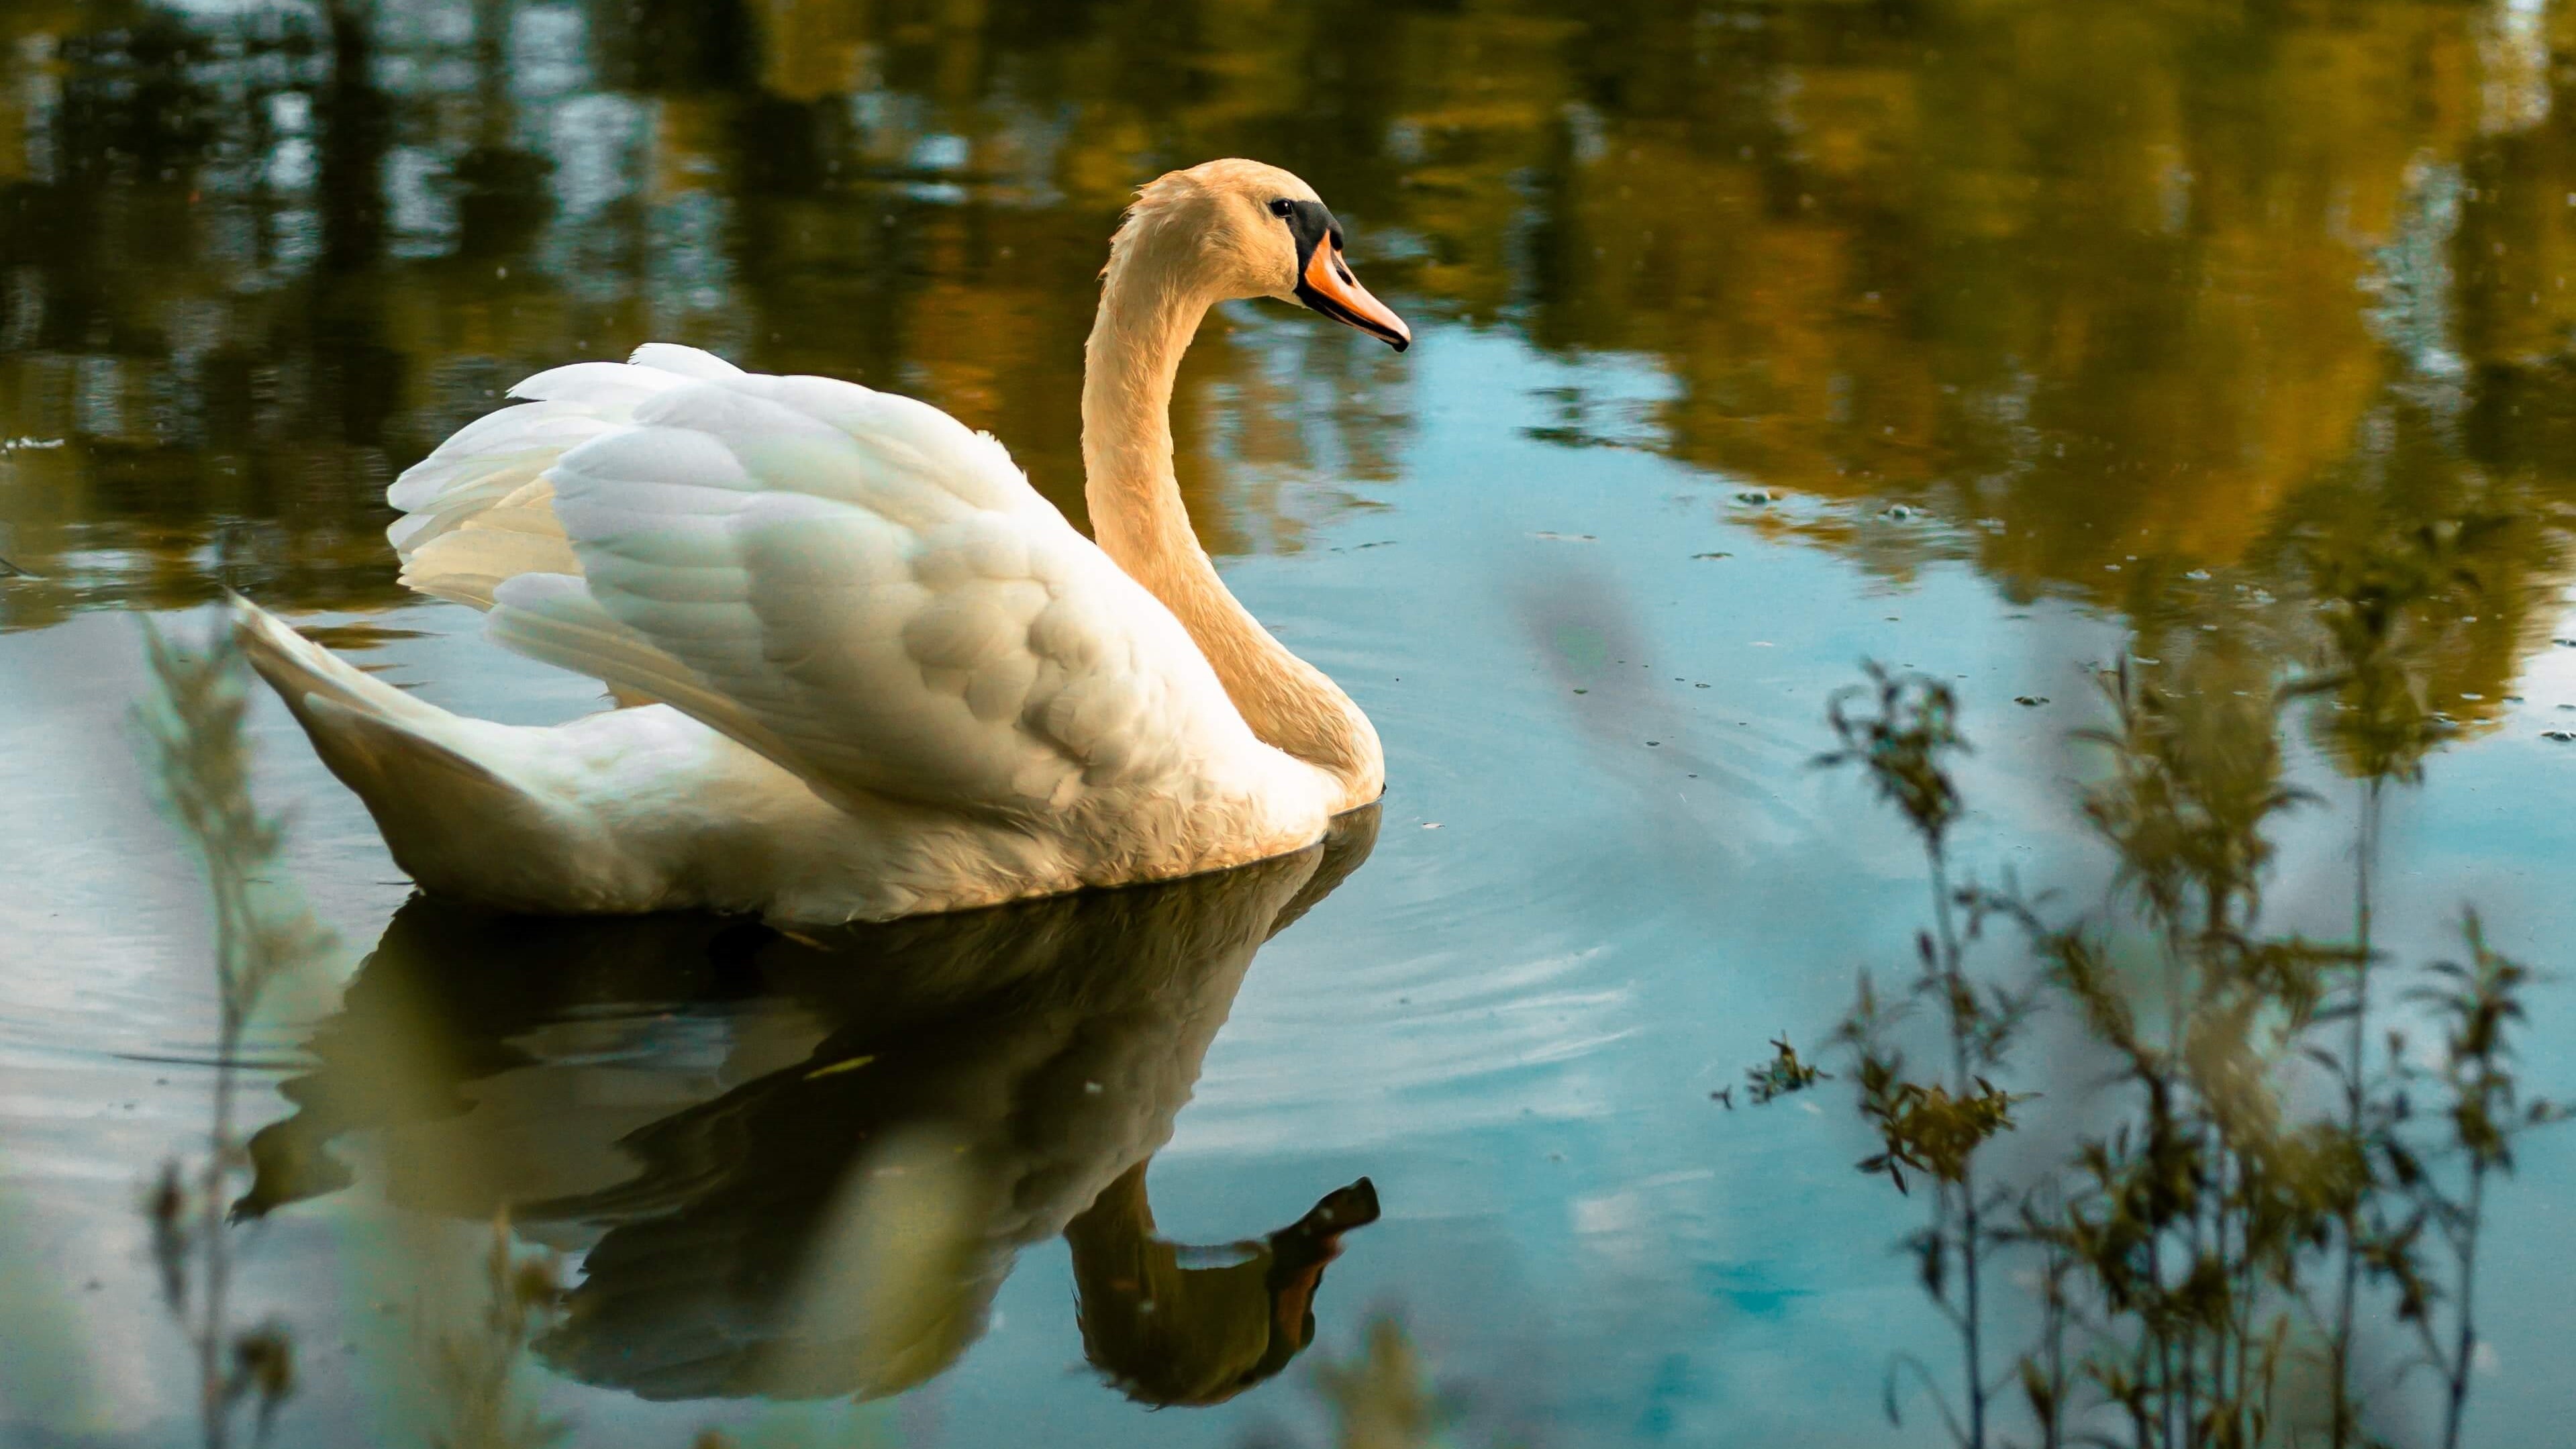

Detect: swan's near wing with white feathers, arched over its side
[492,358,1252,813]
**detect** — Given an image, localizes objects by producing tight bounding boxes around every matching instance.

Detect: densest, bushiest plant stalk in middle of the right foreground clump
[2012,669,2360,1446]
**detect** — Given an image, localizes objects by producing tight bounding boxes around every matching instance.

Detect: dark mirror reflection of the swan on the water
[237,808,1378,1403]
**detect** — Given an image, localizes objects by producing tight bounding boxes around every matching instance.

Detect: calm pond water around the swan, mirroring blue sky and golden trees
[0,0,2576,1446]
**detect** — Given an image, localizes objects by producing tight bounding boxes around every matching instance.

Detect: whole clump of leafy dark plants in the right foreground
[1782,548,2566,1449]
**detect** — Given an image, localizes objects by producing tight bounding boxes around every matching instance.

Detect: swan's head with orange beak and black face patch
[1110,160,1414,352]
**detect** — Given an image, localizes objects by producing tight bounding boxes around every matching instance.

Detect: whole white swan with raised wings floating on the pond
[234,160,1411,921]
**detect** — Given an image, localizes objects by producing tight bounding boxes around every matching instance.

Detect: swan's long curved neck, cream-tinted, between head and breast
[1082,256,1386,811]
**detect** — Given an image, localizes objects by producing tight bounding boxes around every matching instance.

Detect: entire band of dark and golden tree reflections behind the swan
[0,0,2576,715]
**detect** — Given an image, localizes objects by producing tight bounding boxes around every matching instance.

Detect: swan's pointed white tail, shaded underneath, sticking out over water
[230,595,613,911]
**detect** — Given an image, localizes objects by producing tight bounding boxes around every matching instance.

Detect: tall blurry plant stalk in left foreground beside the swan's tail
[136,623,330,1449]
